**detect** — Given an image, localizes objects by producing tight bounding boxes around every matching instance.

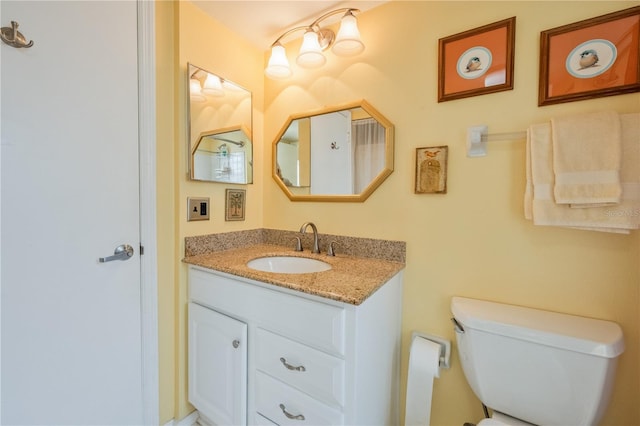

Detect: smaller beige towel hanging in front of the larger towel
[551,111,622,207]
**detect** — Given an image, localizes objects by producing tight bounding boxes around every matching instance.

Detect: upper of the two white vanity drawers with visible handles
[256,329,345,406]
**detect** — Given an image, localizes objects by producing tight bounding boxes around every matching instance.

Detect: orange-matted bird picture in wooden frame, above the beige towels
[538,6,640,106]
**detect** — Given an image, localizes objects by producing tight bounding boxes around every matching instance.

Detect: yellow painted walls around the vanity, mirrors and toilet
[161,1,640,425]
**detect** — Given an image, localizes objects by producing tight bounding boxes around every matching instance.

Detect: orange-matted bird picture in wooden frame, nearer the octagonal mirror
[438,16,516,102]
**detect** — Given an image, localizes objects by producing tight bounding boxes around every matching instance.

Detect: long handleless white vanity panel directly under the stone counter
[189,268,346,355]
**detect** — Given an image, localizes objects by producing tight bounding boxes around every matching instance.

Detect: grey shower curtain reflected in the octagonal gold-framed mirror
[351,118,385,194]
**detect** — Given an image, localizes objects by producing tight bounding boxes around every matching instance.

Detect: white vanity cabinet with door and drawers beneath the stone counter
[189,266,402,426]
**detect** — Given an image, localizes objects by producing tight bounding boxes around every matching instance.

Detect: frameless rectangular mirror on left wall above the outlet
[187,64,253,184]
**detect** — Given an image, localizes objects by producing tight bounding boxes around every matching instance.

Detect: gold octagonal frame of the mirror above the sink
[271,100,394,202]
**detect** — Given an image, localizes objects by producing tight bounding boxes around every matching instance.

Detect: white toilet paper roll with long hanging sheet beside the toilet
[404,336,440,426]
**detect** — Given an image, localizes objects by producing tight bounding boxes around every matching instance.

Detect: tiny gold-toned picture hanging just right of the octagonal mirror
[415,146,449,194]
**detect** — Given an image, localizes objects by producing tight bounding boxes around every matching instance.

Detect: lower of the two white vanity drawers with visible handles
[256,371,343,426]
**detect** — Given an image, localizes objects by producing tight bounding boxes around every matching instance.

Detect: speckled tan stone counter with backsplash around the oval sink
[184,229,405,305]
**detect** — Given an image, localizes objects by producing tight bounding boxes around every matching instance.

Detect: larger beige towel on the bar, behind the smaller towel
[524,114,640,234]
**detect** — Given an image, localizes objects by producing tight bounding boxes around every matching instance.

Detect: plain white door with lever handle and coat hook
[0,0,144,425]
